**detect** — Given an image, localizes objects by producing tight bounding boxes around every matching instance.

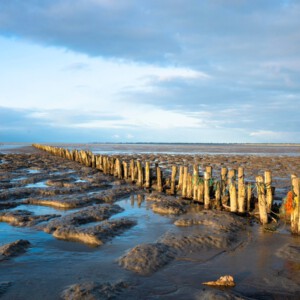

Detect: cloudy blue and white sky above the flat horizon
[0,0,300,143]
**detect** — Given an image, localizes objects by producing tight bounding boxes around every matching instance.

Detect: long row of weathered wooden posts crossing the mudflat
[33,144,300,233]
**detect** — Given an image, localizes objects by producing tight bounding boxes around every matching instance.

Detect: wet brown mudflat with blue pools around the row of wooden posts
[0,145,300,299]
